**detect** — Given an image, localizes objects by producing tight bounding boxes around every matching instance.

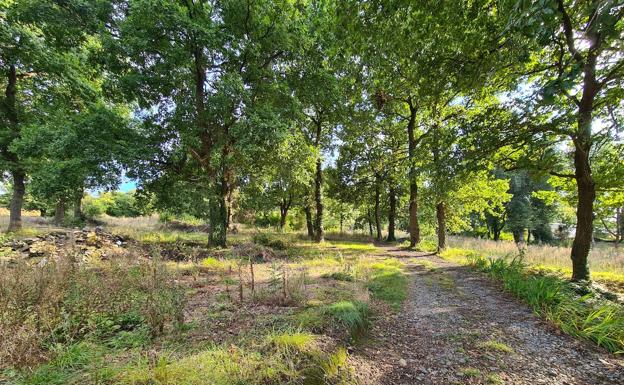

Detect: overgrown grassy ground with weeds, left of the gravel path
[0,222,407,385]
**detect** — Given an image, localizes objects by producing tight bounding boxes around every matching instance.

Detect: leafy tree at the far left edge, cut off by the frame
[0,0,111,231]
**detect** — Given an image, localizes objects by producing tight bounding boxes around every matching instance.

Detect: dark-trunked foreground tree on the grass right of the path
[502,0,624,280]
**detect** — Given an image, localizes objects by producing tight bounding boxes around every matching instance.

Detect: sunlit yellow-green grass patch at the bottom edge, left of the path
[117,332,349,385]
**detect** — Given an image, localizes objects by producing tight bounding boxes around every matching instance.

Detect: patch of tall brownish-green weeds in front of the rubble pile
[0,255,184,366]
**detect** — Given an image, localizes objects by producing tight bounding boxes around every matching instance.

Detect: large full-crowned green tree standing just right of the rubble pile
[109,0,302,246]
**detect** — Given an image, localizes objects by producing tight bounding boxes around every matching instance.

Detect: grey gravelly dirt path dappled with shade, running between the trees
[353,247,624,385]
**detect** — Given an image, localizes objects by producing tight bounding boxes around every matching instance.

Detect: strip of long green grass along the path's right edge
[442,250,624,354]
